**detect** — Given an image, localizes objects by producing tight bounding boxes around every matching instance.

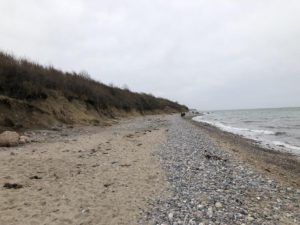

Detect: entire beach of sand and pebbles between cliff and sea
[0,114,300,225]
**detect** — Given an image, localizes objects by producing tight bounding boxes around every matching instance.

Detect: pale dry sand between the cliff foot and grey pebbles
[0,116,167,225]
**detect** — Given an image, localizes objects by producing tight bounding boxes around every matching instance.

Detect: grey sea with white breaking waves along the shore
[193,107,300,155]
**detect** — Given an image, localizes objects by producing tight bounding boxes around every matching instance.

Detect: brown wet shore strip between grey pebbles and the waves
[186,116,300,188]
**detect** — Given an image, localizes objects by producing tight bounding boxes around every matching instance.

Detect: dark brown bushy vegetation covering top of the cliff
[0,52,187,113]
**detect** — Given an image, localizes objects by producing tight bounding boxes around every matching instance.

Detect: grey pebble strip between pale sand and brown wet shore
[143,116,300,225]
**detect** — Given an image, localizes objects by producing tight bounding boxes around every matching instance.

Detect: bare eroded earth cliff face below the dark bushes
[0,94,177,131]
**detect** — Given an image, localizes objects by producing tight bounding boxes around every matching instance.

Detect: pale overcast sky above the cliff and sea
[0,0,300,109]
